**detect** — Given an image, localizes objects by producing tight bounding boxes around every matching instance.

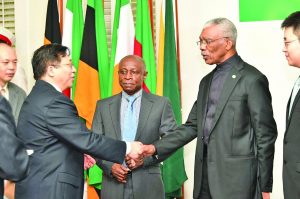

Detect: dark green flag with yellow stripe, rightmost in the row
[157,0,187,198]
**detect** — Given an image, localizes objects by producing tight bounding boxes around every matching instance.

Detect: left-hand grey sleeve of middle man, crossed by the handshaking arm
[92,101,114,177]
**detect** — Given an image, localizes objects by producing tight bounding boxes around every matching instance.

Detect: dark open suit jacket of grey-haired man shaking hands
[156,55,277,199]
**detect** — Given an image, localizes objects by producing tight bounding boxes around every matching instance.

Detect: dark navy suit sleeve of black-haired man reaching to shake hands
[45,95,126,163]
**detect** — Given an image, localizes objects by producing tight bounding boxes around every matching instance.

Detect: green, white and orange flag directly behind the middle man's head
[109,0,135,95]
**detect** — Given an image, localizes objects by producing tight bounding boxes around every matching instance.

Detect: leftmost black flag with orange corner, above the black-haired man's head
[44,0,61,44]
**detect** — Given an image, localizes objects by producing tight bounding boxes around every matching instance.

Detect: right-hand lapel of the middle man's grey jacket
[135,91,153,140]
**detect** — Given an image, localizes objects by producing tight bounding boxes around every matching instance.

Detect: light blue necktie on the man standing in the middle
[122,96,137,142]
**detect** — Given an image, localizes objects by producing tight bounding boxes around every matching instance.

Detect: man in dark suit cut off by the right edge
[281,11,300,199]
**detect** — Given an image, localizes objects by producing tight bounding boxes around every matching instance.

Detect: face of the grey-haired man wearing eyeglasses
[199,25,236,65]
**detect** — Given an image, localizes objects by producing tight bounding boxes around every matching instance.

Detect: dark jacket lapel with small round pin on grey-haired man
[211,63,241,134]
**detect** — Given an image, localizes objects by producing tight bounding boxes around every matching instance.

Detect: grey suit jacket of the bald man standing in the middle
[92,91,177,199]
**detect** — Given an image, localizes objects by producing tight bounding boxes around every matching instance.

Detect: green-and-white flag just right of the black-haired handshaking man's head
[62,0,84,99]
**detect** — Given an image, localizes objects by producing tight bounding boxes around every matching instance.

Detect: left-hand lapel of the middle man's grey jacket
[109,94,122,139]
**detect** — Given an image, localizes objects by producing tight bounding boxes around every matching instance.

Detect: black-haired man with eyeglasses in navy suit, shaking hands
[15,44,141,199]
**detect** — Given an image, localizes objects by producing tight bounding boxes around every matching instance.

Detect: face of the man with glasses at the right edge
[282,27,300,68]
